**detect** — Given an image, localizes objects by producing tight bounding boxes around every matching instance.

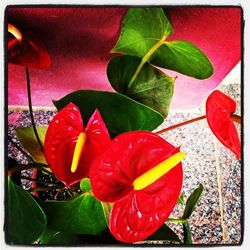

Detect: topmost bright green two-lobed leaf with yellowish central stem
[112,8,213,79]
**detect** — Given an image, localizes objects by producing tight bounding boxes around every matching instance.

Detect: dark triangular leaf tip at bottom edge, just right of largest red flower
[147,224,181,243]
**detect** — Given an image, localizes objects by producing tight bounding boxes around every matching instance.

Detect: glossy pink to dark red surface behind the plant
[8,7,241,109]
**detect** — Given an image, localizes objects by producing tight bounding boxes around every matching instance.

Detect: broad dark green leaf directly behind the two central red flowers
[54,90,164,137]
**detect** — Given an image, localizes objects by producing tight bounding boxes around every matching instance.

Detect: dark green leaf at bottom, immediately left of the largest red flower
[41,193,107,235]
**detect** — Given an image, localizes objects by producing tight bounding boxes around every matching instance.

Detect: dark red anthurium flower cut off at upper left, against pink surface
[8,24,51,69]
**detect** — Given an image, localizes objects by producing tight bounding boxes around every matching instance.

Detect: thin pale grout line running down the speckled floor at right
[213,135,227,244]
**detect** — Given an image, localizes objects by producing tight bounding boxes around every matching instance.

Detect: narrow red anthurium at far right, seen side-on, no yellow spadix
[206,90,241,158]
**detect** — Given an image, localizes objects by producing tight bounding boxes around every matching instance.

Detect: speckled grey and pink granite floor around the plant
[8,83,242,244]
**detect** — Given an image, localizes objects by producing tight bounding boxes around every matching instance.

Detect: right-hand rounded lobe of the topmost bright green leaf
[150,41,213,79]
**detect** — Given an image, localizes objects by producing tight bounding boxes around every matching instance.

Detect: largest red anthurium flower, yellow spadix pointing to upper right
[90,131,184,243]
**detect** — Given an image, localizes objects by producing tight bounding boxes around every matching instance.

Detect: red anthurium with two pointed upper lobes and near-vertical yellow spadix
[44,103,110,186]
